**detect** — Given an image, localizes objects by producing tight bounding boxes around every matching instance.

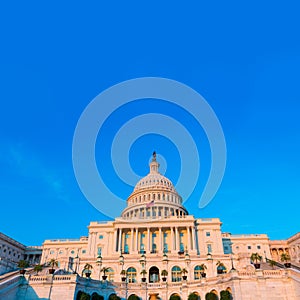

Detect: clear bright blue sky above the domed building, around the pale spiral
[0,1,300,245]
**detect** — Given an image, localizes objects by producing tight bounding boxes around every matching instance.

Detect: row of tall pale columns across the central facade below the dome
[114,226,197,253]
